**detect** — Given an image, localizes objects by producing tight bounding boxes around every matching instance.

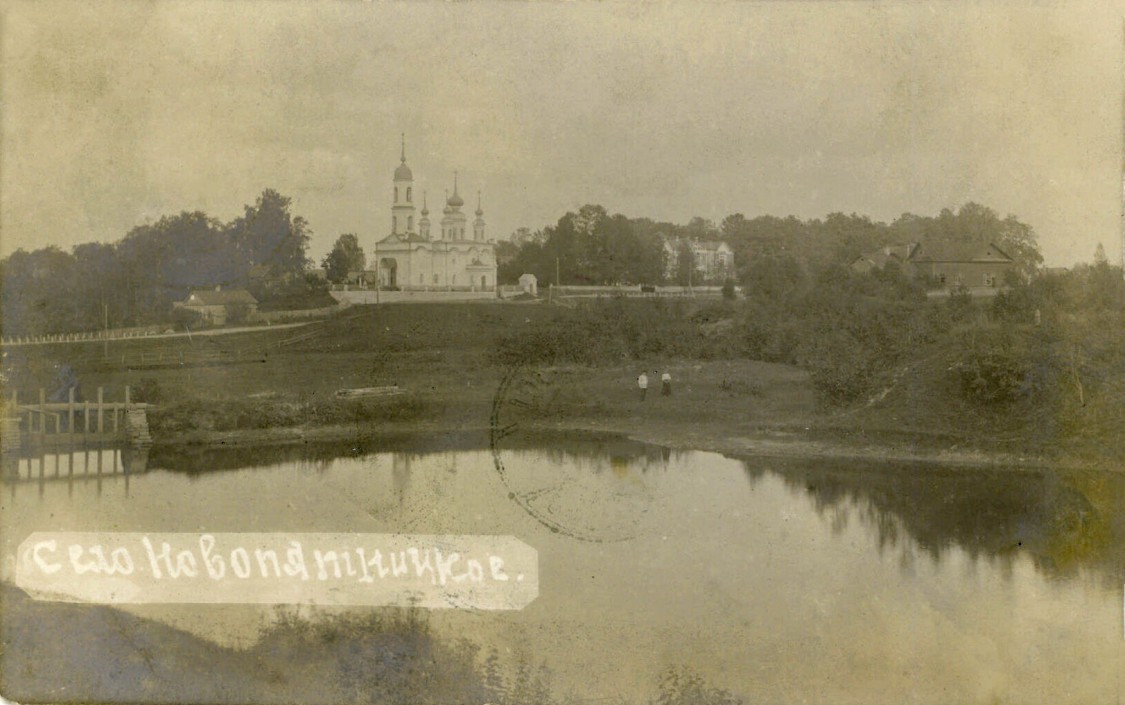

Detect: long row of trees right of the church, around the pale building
[497,202,1043,287]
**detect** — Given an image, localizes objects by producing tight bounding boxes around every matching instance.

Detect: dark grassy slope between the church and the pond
[5,302,1107,470]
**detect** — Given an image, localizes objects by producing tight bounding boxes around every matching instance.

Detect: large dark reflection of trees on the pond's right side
[744,461,1125,585]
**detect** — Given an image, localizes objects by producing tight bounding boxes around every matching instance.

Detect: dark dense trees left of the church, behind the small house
[0,189,326,336]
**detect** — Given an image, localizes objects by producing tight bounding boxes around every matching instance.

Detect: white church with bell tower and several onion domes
[370,142,496,291]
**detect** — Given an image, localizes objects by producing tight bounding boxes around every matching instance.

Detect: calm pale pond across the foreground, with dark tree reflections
[2,437,1125,703]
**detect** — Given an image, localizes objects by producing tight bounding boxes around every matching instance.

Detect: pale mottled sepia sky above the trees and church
[0,0,1123,264]
